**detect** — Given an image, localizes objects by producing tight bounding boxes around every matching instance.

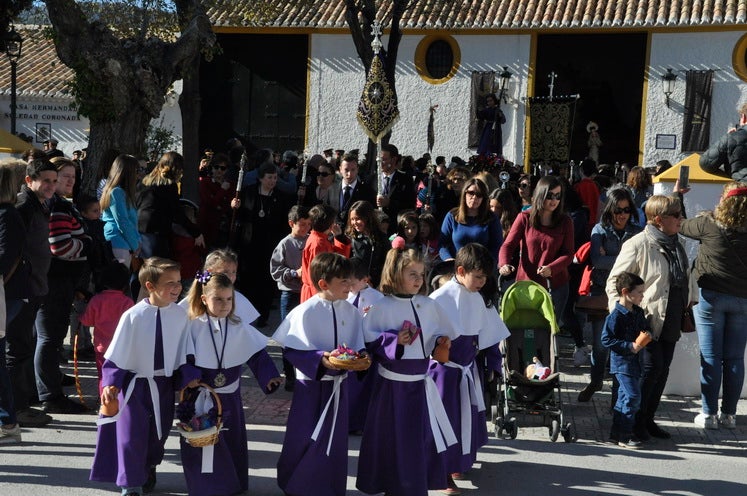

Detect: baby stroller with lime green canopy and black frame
[491,281,574,443]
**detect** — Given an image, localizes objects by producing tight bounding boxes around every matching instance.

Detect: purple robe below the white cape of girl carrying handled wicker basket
[181,350,280,496]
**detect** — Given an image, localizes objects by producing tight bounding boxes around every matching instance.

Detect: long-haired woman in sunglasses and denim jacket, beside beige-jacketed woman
[578,187,643,406]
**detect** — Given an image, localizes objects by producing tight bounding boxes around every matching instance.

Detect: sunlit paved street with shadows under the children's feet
[0,316,747,496]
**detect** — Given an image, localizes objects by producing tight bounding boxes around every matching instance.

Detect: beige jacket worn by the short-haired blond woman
[605,230,697,339]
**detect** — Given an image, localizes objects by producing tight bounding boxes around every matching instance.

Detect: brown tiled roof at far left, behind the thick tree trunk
[0,26,73,97]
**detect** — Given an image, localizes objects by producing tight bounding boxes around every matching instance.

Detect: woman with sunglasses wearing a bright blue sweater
[438,177,503,260]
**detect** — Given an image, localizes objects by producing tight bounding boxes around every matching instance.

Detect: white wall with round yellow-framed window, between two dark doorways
[308,35,530,161]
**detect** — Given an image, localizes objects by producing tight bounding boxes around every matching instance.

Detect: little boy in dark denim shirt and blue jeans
[602,272,651,449]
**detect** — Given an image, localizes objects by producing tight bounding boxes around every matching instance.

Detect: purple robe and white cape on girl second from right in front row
[356,296,455,496]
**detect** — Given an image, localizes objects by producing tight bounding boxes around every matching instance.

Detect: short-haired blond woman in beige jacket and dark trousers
[605,195,694,441]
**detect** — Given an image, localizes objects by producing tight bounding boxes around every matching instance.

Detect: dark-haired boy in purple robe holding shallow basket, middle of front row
[272,253,365,496]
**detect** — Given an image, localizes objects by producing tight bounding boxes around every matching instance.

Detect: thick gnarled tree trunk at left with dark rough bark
[44,0,216,198]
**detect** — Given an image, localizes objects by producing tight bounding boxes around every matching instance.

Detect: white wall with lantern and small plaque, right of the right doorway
[644,31,747,165]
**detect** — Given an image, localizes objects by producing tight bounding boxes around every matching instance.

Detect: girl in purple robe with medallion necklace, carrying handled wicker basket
[181,271,282,496]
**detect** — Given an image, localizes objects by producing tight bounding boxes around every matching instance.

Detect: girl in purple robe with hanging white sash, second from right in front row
[356,248,457,496]
